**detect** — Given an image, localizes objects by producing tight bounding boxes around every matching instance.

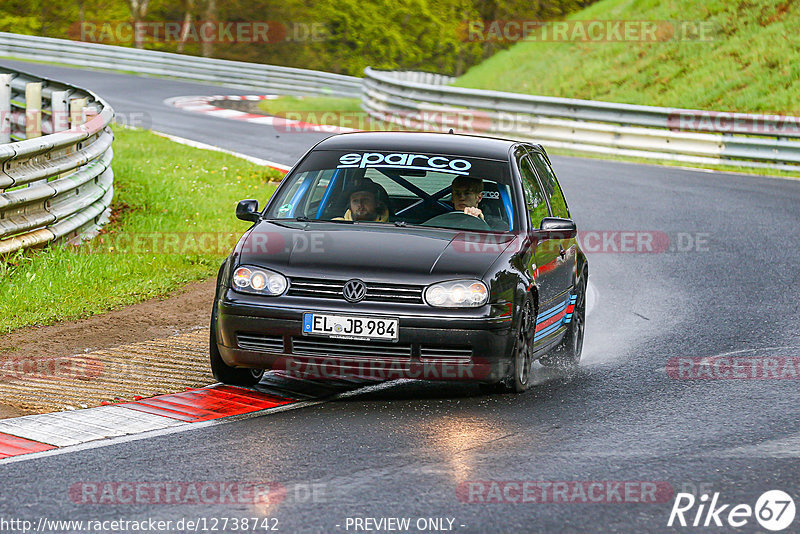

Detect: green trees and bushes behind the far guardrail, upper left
[0,0,591,76]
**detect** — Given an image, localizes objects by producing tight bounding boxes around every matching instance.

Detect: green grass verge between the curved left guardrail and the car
[0,128,282,333]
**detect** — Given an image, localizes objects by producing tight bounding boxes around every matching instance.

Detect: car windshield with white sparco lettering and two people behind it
[265,150,516,232]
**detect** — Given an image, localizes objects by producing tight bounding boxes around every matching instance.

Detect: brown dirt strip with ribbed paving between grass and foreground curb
[0,278,216,418]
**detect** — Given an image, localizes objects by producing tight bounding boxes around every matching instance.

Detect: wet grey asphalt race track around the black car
[0,61,800,532]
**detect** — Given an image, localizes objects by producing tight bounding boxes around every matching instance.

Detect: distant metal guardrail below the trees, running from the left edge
[0,32,361,98]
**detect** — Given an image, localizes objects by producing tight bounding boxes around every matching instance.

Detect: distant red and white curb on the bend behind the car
[164,95,358,134]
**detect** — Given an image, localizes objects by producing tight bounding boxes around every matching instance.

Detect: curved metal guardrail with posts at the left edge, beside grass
[0,67,114,254]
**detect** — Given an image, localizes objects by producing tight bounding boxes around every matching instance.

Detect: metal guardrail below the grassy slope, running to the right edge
[362,68,800,171]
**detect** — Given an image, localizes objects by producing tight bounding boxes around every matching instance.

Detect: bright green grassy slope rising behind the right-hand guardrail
[455,0,800,115]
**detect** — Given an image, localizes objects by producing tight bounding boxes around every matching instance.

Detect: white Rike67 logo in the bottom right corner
[667,490,795,532]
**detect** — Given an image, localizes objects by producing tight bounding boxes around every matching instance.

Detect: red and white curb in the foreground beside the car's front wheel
[0,382,394,465]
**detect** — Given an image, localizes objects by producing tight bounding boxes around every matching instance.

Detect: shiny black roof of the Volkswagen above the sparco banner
[314,132,536,161]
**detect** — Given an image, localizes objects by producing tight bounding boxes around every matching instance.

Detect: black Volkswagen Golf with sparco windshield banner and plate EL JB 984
[210,132,589,392]
